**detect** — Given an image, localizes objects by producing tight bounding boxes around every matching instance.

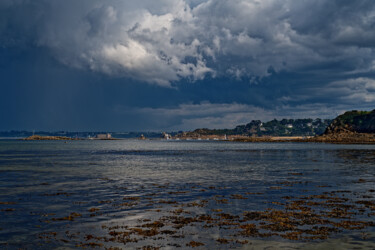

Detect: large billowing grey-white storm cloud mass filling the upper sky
[0,0,375,86]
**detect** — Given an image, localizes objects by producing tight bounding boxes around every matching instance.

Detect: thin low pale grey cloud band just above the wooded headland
[116,102,362,131]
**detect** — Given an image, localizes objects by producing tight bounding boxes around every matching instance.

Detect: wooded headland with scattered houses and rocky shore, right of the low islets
[175,110,375,143]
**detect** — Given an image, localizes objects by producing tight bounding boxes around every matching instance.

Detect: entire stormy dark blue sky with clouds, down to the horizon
[0,0,375,132]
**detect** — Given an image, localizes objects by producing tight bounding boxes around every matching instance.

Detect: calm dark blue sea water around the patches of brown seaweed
[0,140,375,249]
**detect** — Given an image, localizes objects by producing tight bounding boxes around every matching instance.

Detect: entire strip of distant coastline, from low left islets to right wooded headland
[7,110,375,144]
